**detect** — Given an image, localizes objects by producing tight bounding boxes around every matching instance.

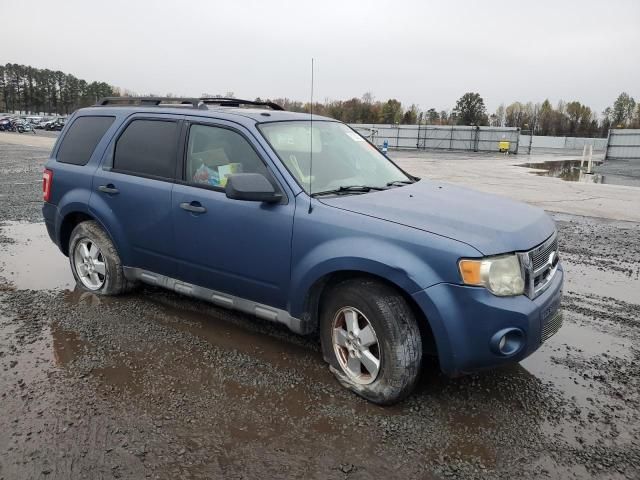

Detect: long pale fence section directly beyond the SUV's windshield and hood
[350,123,520,153]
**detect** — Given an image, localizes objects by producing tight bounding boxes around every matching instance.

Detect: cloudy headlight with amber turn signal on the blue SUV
[458,254,524,297]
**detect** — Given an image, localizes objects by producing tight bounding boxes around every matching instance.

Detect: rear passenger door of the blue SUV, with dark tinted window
[90,114,182,278]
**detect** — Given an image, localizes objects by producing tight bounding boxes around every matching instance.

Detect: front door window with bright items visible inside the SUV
[185,125,271,188]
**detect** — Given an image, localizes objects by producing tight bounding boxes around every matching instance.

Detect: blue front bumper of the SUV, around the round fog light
[413,266,564,375]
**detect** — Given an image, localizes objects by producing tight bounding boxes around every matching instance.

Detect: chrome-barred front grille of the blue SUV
[519,233,560,298]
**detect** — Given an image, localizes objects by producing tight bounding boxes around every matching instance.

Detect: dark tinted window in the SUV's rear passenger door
[113,120,178,178]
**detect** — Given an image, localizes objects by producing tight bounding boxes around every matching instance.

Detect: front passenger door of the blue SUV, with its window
[172,120,295,309]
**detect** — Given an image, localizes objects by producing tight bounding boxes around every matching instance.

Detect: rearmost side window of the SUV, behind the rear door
[56,117,115,165]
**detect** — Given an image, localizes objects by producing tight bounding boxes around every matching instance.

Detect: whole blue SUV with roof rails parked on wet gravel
[43,98,563,404]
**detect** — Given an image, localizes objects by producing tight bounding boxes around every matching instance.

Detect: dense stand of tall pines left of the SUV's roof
[0,63,119,114]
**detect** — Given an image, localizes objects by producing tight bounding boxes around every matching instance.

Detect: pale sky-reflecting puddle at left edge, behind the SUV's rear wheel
[0,222,76,290]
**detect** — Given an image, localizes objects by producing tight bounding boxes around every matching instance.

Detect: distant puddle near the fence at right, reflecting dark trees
[517,160,640,187]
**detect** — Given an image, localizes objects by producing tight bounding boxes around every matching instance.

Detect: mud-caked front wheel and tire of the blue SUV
[320,279,422,405]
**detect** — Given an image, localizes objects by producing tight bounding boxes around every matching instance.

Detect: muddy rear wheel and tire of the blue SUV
[69,220,134,295]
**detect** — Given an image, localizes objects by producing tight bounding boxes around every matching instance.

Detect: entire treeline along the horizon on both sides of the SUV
[0,63,640,137]
